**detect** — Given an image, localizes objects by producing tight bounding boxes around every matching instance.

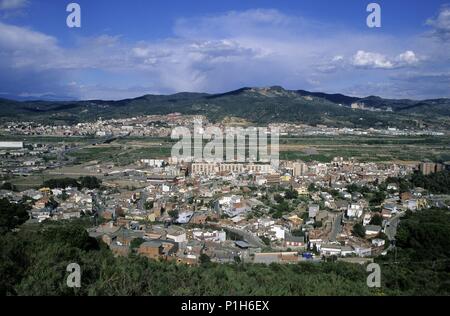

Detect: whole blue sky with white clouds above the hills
[0,0,450,99]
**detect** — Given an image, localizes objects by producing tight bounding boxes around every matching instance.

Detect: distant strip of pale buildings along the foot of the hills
[0,113,446,137]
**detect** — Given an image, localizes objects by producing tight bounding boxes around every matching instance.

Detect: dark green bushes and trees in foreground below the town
[0,196,450,296]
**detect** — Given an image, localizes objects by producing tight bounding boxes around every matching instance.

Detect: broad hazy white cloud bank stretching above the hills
[0,10,442,99]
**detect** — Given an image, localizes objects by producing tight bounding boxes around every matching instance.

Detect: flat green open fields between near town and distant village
[4,136,450,189]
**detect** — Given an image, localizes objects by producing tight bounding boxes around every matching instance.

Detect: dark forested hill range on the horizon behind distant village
[0,87,450,128]
